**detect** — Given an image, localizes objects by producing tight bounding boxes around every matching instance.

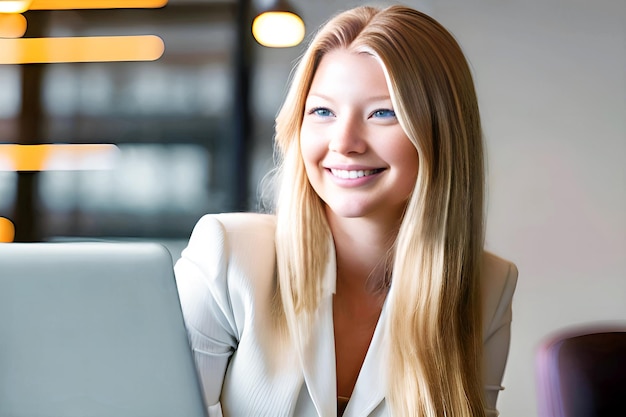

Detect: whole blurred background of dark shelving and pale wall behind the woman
[0,0,626,417]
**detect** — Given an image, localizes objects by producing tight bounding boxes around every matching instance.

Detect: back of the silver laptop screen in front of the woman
[0,242,205,417]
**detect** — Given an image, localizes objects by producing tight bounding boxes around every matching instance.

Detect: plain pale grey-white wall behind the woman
[259,0,626,417]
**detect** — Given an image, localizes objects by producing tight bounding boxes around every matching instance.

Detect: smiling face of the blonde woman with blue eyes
[300,50,418,223]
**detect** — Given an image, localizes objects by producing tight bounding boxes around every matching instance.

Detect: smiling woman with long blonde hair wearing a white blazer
[176,6,517,417]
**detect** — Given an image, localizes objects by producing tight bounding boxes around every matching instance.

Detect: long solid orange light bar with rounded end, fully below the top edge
[0,35,165,64]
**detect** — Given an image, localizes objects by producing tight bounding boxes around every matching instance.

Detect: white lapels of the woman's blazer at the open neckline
[301,242,387,417]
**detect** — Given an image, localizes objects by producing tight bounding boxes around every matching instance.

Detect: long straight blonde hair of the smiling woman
[276,6,484,417]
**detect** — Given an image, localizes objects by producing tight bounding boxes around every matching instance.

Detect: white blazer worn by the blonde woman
[175,213,517,417]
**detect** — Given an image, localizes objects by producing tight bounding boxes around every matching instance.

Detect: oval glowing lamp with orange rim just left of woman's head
[252,12,305,48]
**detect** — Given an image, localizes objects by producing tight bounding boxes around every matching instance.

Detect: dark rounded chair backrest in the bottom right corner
[536,324,626,417]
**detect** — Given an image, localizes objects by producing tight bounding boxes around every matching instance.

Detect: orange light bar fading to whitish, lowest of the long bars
[0,144,120,171]
